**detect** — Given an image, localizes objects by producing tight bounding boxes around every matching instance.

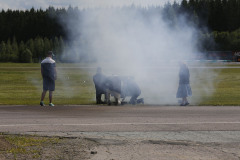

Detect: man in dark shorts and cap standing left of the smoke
[40,51,57,106]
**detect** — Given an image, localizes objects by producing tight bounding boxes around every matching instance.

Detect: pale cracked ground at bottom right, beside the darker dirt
[91,141,240,160]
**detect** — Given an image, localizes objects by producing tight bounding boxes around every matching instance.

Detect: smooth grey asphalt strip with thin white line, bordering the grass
[0,105,240,132]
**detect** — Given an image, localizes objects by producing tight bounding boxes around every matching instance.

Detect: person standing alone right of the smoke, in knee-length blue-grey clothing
[177,62,192,106]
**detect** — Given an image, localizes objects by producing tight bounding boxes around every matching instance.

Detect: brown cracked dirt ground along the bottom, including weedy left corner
[0,135,240,160]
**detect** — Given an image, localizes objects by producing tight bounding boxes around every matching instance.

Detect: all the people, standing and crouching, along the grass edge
[40,51,192,106]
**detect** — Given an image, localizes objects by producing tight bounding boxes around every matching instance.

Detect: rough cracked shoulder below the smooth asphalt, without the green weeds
[0,131,240,160]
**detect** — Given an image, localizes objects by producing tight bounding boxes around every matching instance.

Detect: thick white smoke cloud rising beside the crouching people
[59,6,216,105]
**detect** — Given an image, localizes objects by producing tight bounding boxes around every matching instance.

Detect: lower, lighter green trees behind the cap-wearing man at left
[0,37,65,63]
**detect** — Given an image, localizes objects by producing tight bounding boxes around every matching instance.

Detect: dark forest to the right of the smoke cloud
[169,0,240,51]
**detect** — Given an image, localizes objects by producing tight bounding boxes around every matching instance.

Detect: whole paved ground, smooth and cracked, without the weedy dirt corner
[0,105,240,160]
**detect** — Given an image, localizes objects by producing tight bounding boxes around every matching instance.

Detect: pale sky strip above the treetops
[0,0,182,10]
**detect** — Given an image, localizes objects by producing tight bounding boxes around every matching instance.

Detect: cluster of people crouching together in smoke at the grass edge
[93,67,144,105]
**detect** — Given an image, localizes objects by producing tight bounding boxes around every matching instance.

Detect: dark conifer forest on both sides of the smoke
[0,0,240,62]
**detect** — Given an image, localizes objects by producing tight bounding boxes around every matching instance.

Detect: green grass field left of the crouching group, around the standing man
[0,63,95,105]
